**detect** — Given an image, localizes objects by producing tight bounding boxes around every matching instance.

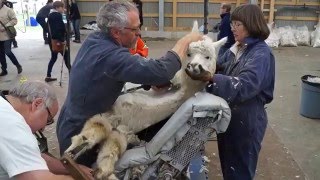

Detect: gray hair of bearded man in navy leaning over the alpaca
[96,0,139,33]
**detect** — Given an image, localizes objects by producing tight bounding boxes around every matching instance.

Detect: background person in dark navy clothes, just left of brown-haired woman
[217,3,235,57]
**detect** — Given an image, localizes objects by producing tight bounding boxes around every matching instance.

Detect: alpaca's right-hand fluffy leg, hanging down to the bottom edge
[95,131,127,180]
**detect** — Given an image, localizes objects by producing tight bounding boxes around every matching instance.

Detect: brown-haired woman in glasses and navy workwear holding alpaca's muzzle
[195,4,275,180]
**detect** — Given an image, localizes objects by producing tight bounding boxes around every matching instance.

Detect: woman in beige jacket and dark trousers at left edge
[0,0,22,76]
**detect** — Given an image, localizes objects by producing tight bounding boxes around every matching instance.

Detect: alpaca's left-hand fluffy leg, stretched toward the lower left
[65,116,112,159]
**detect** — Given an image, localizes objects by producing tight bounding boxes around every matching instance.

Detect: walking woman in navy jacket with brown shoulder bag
[45,1,71,82]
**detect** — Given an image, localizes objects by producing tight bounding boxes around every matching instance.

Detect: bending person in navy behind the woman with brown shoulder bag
[36,0,53,44]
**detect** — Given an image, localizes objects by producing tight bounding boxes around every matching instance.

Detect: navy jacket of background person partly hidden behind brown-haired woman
[217,13,235,48]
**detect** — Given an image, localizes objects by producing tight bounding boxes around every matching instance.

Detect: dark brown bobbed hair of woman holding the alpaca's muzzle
[231,4,270,40]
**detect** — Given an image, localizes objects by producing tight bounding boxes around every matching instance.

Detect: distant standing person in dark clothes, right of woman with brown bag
[70,0,81,43]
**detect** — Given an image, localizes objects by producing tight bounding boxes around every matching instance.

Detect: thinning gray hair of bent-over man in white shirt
[9,81,57,107]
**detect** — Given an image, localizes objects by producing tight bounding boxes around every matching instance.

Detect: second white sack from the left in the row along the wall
[279,26,298,47]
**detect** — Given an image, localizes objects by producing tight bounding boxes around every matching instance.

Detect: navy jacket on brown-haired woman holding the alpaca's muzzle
[212,38,275,105]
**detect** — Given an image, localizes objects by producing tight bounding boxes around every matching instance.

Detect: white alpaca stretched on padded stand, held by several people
[66,22,227,179]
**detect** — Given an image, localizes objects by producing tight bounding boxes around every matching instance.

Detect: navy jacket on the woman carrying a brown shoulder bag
[48,12,66,42]
